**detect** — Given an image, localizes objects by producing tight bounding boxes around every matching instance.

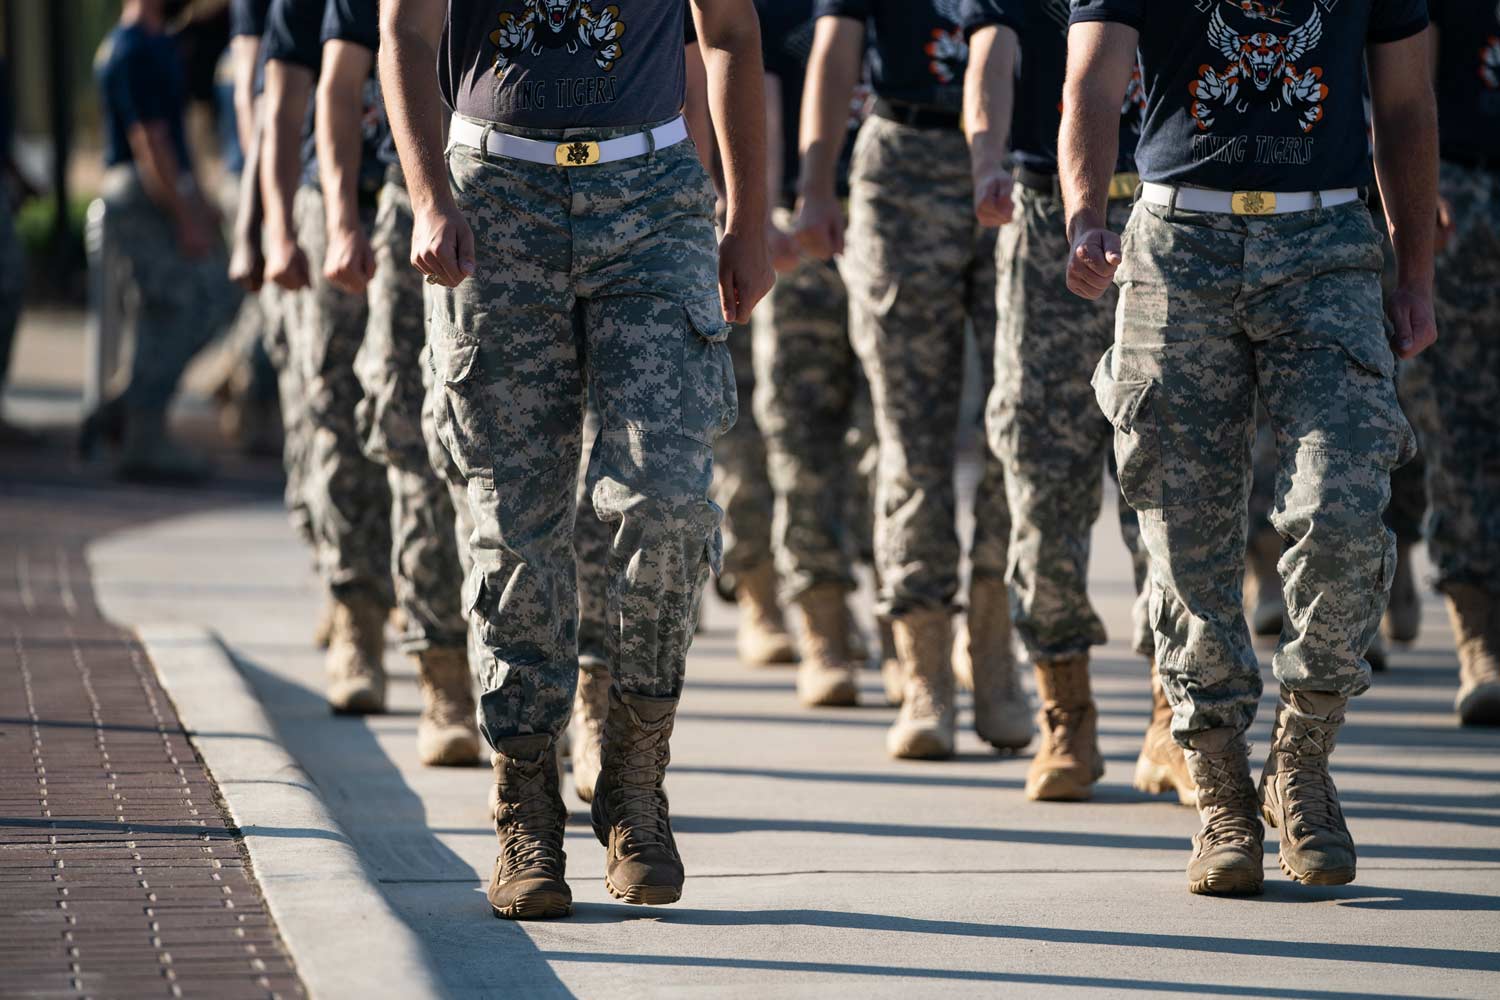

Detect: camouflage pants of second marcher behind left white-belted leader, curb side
[287,187,393,604]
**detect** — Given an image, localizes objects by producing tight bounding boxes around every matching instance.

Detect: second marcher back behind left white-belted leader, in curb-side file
[261,0,395,714]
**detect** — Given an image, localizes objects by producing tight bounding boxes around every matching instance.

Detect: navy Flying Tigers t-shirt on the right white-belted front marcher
[1073,0,1427,192]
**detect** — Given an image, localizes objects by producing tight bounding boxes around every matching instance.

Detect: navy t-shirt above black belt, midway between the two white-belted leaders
[816,0,969,112]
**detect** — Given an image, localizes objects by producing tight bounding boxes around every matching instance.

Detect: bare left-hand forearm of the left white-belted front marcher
[380,0,453,210]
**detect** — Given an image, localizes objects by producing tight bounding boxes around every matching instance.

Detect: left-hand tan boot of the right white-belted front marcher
[1187,729,1266,897]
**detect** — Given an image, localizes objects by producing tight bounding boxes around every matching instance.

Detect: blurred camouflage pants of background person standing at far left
[104,166,240,412]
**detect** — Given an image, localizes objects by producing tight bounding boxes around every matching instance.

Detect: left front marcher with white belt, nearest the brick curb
[380,0,771,919]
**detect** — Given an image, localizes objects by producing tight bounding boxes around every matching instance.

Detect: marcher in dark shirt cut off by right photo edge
[1418,0,1500,726]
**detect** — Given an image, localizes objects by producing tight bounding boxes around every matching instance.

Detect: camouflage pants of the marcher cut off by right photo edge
[1416,163,1500,594]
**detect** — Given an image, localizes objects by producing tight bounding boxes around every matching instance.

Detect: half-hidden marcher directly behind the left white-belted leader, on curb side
[315,0,479,766]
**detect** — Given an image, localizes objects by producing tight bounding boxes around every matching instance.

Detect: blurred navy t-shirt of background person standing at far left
[95,24,192,172]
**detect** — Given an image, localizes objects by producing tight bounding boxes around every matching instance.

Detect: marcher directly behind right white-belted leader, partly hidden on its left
[963,0,1194,804]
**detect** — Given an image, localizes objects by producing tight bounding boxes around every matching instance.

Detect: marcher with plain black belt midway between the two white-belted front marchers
[797,0,1014,757]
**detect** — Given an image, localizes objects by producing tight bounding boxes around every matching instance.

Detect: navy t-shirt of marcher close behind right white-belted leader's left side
[960,0,1142,174]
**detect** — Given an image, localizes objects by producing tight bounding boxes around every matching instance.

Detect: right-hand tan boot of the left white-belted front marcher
[591,687,684,906]
